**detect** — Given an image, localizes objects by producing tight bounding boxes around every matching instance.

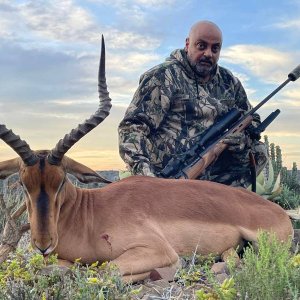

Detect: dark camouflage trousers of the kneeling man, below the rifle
[199,141,268,188]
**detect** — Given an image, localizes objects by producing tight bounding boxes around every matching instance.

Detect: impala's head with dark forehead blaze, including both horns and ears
[0,36,111,255]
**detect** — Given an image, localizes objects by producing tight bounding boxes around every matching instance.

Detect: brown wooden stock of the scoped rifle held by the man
[178,115,253,179]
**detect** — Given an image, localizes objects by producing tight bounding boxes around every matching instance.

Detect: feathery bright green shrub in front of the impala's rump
[231,232,300,300]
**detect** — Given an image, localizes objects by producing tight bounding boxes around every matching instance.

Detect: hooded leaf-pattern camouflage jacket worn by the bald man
[119,49,259,175]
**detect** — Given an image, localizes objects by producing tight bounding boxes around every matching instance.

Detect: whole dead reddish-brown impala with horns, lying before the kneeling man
[0,36,293,281]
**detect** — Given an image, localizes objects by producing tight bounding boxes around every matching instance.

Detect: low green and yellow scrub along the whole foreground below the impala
[0,232,300,300]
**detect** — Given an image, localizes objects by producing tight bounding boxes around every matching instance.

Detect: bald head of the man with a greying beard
[185,21,222,81]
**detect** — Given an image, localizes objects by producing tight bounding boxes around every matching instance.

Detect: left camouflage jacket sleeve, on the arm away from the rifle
[118,73,169,176]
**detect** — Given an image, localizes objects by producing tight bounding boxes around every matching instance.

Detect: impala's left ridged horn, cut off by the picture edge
[0,124,38,166]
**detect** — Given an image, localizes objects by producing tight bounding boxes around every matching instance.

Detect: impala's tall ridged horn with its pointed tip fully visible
[48,35,111,165]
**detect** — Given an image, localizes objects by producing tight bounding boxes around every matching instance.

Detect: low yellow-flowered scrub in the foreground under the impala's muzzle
[0,250,134,300]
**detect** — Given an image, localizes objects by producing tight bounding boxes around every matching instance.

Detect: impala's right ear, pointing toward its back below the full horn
[62,156,111,183]
